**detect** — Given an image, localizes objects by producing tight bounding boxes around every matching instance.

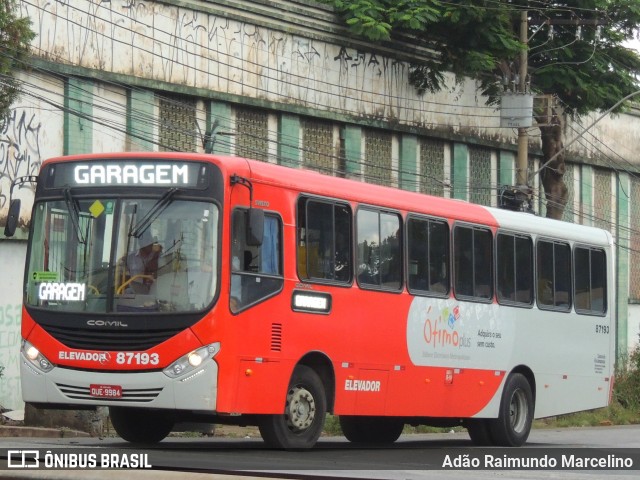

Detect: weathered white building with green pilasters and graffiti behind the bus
[0,0,640,408]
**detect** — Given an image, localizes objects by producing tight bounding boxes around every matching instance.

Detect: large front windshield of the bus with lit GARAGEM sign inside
[26,196,219,313]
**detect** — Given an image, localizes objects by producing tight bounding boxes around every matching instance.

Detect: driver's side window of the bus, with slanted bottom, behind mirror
[229,208,284,313]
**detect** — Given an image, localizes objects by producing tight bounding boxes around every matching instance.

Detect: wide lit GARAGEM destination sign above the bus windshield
[48,161,206,188]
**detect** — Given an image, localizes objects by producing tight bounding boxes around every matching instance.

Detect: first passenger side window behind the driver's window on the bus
[296,197,352,283]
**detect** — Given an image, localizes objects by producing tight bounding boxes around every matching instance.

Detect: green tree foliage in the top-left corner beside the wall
[0,0,35,123]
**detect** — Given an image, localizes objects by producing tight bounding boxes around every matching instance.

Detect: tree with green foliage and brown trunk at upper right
[324,0,640,218]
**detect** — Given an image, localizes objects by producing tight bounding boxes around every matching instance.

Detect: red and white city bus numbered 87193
[7,153,616,449]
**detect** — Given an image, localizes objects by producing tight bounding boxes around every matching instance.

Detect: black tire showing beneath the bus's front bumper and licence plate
[109,407,174,444]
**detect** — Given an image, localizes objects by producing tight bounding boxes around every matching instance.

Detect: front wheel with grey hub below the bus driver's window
[259,365,327,450]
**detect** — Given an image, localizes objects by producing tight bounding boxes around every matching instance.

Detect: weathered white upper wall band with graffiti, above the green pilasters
[12,0,640,164]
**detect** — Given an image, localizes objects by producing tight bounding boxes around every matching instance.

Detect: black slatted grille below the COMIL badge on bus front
[43,325,183,351]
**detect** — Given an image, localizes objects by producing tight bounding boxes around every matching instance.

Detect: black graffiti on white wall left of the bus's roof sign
[0,108,42,225]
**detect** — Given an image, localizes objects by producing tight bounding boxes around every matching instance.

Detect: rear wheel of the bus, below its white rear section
[489,373,534,447]
